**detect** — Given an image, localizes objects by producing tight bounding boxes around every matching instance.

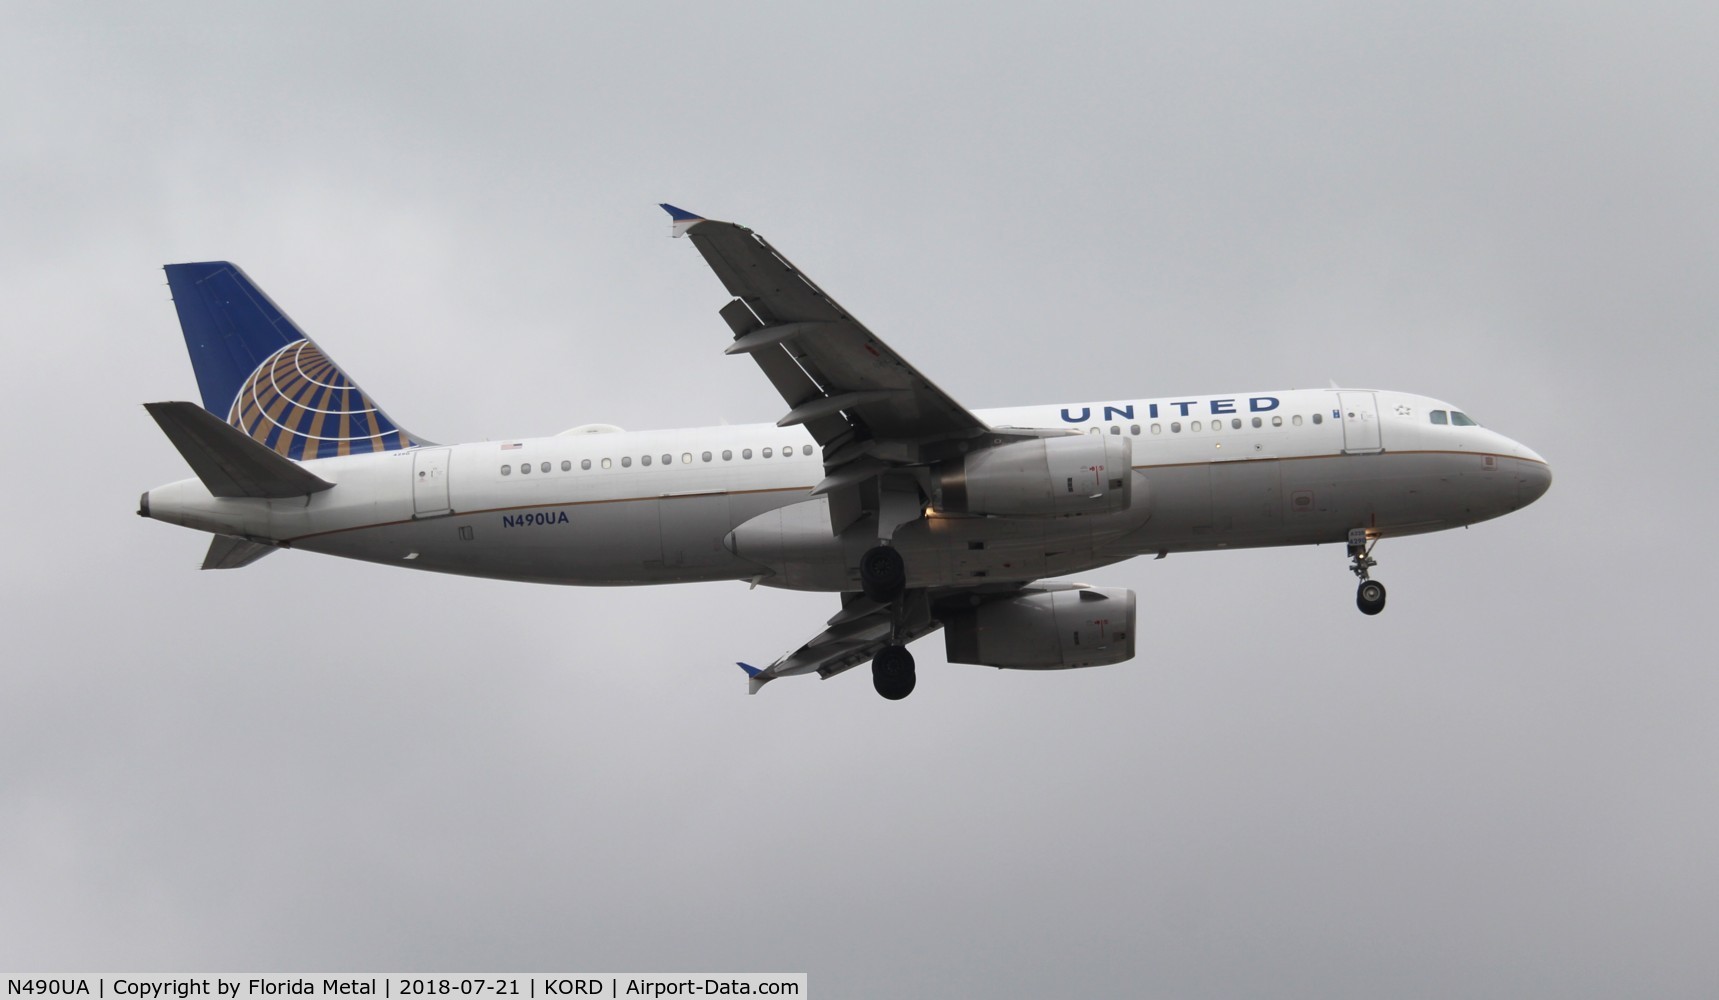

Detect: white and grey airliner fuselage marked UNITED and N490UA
[144,390,1551,591]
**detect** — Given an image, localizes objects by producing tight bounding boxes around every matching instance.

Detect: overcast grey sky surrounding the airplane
[0,2,1719,998]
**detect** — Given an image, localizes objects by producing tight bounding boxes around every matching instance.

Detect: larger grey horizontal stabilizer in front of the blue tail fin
[143,402,333,498]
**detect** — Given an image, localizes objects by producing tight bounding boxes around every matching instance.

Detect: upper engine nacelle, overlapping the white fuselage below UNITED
[937,435,1135,517]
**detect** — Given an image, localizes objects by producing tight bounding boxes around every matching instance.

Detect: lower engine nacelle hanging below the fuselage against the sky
[942,588,1135,670]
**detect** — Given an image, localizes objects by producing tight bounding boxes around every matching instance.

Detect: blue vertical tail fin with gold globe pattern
[167,261,428,460]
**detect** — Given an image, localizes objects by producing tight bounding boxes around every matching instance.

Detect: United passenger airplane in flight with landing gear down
[138,204,1552,699]
